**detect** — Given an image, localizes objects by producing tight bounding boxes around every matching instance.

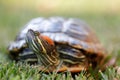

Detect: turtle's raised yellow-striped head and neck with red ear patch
[25,29,58,66]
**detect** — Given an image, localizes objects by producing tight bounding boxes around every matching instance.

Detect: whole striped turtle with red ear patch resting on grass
[8,17,106,72]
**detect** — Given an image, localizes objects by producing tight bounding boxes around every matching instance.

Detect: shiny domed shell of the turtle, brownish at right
[8,17,105,72]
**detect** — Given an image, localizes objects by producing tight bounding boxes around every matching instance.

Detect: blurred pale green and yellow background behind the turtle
[0,0,120,61]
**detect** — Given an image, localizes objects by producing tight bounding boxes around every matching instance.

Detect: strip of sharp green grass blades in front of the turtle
[0,62,120,80]
